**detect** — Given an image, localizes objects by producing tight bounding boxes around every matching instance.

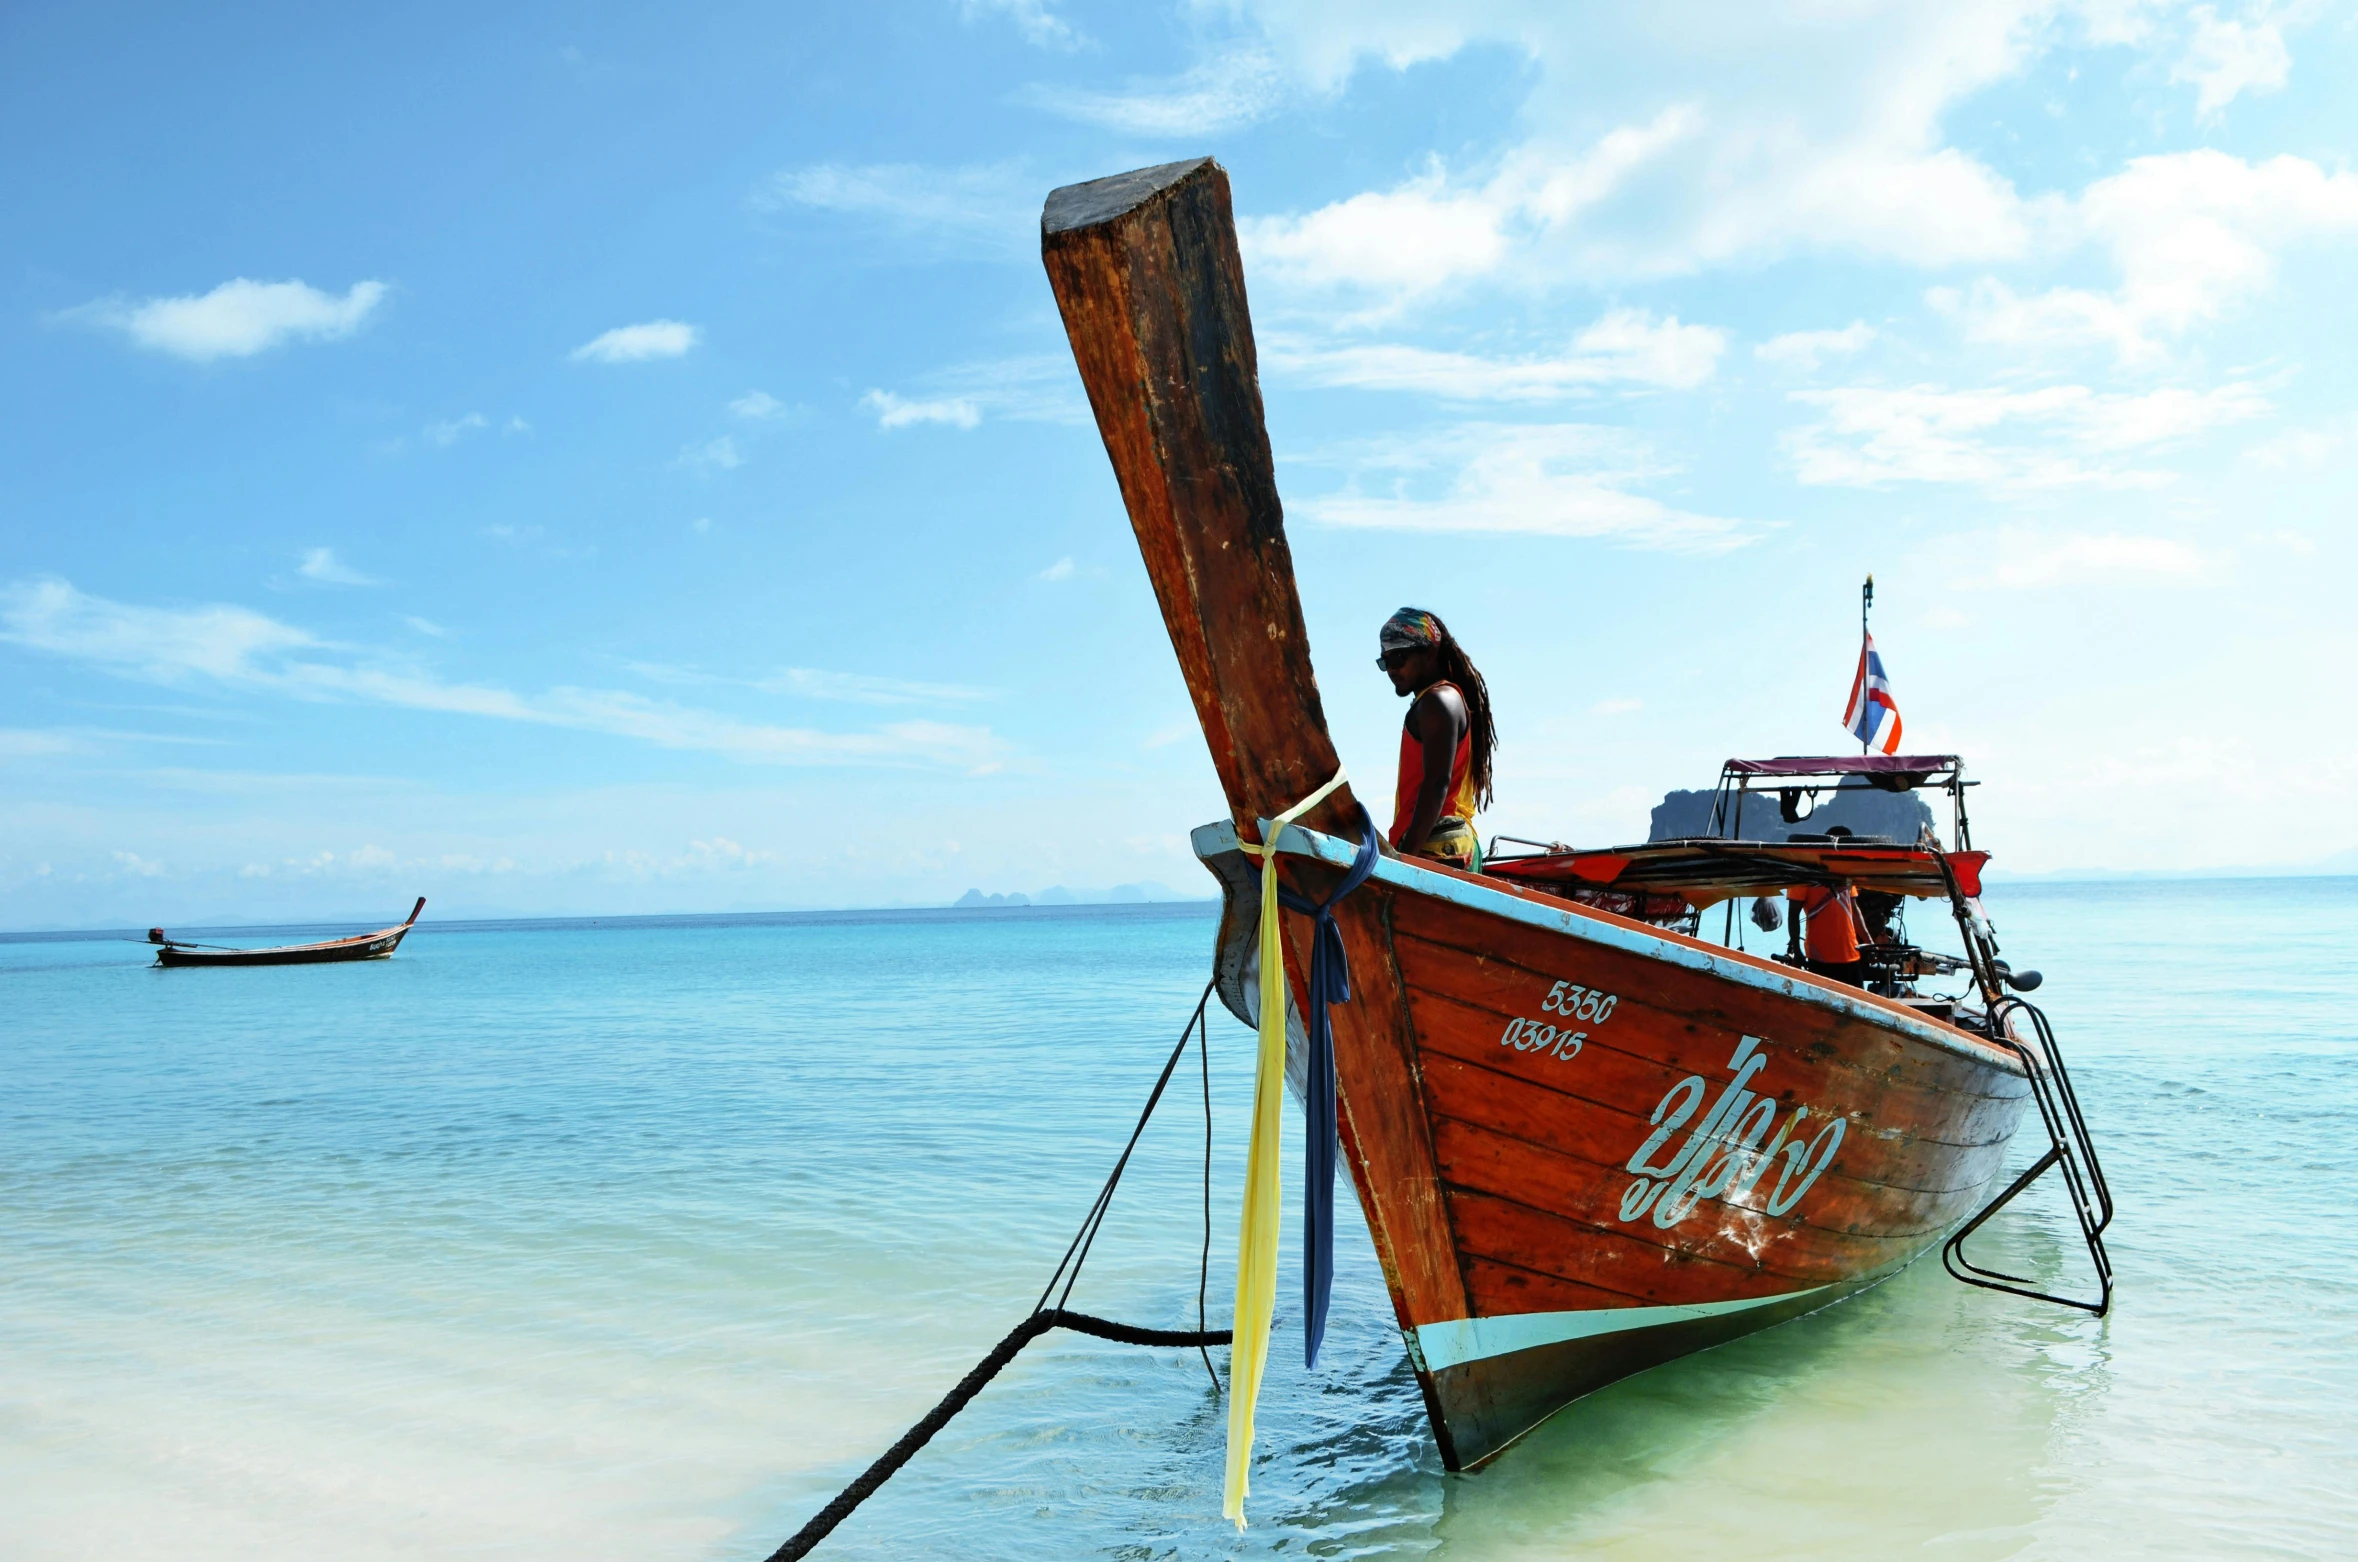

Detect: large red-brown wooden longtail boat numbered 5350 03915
[1042,158,2110,1470]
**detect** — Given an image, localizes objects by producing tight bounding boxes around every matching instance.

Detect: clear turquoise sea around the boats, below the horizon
[0,880,2358,1562]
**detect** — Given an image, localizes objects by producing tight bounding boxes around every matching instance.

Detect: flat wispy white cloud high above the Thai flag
[1785,382,2268,488]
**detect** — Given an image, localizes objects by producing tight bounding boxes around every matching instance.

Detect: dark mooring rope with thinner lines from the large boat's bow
[769,984,1231,1562]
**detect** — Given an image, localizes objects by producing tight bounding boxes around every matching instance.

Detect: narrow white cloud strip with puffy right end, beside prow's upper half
[1262,309,1728,401]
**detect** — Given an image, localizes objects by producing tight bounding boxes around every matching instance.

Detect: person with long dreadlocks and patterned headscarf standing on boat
[1375,606,1497,871]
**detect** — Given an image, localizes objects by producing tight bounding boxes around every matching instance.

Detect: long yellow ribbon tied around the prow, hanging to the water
[1219,769,1344,1529]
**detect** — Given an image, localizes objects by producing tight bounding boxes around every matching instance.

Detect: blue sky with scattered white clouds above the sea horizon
[0,0,2358,927]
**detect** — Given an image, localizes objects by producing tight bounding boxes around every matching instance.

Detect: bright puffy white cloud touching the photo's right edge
[1929,149,2358,361]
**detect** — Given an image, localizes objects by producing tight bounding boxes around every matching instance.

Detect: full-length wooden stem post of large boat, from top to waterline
[1040,158,1467,1468]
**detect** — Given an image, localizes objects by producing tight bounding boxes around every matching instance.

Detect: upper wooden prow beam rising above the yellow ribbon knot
[1040,158,1358,840]
